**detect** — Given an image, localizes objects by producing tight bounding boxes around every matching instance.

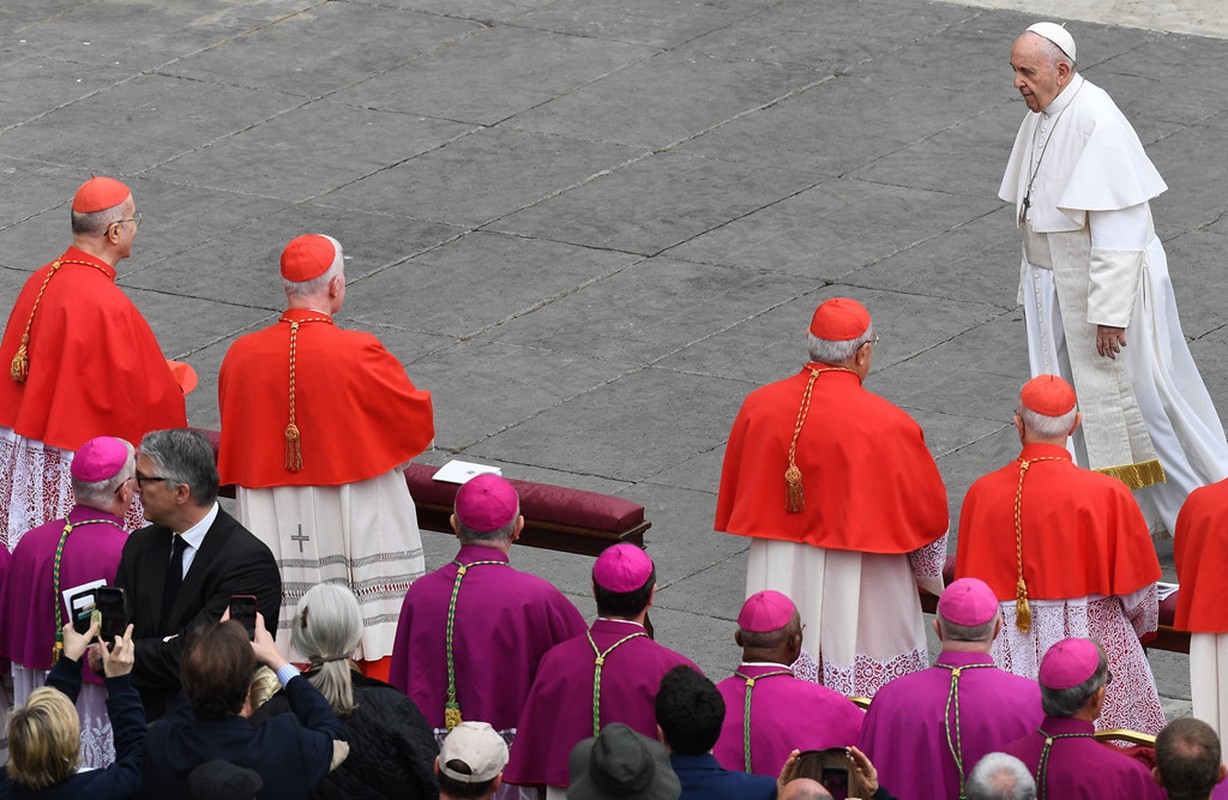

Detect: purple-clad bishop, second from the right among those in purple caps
[860,578,1044,800]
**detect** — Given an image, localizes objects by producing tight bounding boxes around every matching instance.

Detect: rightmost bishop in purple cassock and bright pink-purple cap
[1002,639,1165,800]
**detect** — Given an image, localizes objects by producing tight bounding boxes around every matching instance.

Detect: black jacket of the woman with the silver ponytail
[252,671,440,800]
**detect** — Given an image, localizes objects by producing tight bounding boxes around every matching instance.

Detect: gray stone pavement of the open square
[0,0,1228,713]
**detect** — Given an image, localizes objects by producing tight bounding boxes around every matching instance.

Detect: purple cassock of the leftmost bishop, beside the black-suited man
[0,505,128,684]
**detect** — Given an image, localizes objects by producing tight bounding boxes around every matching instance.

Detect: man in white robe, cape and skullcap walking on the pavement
[998,22,1228,531]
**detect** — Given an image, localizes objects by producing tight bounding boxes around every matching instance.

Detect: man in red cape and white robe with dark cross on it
[217,233,435,681]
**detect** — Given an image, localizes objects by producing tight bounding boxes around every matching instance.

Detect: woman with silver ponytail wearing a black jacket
[252,584,440,800]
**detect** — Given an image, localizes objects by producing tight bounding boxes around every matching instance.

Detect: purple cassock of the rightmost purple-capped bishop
[1002,716,1168,800]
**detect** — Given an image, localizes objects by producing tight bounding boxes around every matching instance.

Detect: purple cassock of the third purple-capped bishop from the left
[503,619,700,786]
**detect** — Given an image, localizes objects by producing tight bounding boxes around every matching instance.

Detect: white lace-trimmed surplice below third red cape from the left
[747,536,947,697]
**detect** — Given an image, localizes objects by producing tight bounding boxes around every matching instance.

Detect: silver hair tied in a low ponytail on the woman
[290,584,362,716]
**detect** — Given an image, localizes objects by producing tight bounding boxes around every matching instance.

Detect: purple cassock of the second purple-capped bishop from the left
[389,544,585,731]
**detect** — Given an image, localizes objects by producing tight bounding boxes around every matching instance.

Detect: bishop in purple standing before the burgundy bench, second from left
[389,474,585,734]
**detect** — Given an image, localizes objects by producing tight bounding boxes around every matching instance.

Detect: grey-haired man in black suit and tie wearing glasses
[115,428,281,721]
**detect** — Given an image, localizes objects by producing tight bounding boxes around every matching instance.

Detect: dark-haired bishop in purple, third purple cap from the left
[503,544,699,786]
